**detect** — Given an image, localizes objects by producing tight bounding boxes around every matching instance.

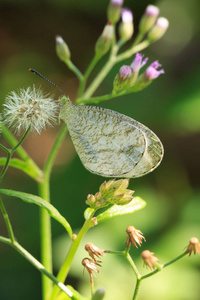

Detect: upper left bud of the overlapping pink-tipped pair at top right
[139,5,159,34]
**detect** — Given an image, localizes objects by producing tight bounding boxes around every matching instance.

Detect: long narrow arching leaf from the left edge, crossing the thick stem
[0,189,72,237]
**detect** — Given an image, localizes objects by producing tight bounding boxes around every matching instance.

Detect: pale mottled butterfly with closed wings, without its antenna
[59,96,164,178]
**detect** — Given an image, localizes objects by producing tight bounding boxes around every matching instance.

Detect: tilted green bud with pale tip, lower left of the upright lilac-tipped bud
[95,23,114,57]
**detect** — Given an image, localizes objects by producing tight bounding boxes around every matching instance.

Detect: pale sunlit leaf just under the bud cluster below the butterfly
[97,197,146,224]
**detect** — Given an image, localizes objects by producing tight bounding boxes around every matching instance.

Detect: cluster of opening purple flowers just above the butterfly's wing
[113,53,164,93]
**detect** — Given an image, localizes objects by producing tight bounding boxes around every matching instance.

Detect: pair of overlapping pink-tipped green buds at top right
[139,5,169,42]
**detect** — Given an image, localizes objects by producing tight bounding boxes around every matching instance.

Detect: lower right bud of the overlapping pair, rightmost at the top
[147,17,169,42]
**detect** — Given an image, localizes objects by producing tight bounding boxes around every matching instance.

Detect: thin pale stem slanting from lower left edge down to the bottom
[0,236,76,299]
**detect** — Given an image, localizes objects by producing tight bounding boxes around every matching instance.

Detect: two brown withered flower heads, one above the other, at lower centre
[82,243,105,284]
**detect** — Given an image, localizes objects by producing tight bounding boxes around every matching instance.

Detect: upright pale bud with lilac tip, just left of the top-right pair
[119,9,134,41]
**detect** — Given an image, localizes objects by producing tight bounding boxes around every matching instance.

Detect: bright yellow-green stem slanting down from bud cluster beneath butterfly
[50,216,94,300]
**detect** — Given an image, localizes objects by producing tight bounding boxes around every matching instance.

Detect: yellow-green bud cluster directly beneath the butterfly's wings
[86,179,134,209]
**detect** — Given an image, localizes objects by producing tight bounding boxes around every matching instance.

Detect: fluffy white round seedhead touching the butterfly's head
[3,86,59,134]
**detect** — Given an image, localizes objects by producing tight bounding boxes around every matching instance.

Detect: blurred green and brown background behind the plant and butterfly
[0,0,200,300]
